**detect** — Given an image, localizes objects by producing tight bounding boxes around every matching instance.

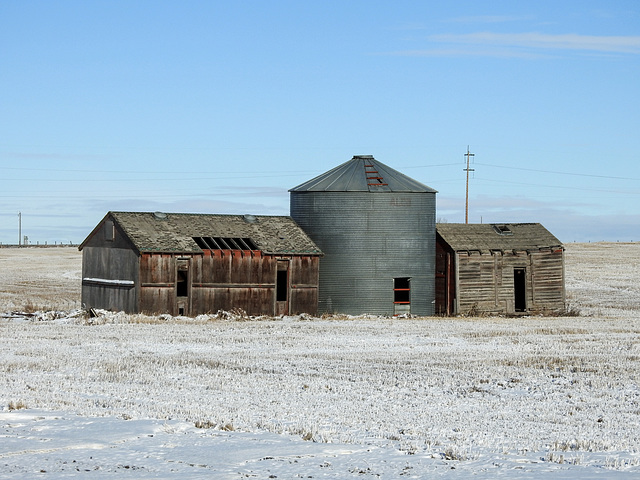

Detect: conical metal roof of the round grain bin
[289,155,436,193]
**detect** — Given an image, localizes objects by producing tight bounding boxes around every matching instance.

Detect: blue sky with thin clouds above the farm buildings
[0,0,640,244]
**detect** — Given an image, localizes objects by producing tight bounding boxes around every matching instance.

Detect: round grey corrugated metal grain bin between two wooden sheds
[289,155,436,315]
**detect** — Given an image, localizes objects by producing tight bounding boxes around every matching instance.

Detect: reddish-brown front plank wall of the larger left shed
[140,250,319,316]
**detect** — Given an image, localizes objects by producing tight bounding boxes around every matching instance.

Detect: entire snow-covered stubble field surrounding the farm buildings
[0,243,640,479]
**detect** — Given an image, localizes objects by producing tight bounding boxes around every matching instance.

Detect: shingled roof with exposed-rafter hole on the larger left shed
[80,212,322,255]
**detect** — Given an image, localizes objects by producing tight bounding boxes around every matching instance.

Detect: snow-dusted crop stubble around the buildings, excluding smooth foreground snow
[0,244,640,465]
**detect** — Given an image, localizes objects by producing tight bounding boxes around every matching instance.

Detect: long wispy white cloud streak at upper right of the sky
[394,32,640,58]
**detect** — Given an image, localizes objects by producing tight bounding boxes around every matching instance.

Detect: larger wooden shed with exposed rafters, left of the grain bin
[79,212,322,316]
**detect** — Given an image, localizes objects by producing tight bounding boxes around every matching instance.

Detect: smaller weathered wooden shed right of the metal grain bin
[436,223,565,315]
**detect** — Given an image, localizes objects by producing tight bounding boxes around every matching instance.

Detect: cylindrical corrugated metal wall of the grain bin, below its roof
[290,191,436,315]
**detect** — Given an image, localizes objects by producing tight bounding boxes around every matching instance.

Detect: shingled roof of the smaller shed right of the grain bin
[436,223,562,253]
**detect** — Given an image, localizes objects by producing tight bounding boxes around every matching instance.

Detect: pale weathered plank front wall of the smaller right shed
[456,249,565,314]
